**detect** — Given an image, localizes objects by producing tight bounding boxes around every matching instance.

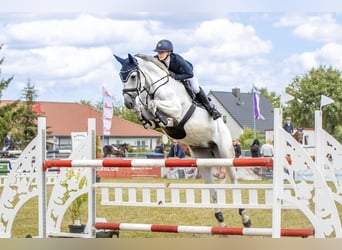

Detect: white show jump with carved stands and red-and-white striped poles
[0,109,342,238]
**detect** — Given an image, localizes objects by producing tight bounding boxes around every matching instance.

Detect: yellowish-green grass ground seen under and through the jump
[0,179,324,238]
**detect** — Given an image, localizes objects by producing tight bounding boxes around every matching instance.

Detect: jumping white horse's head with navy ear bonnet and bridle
[114,54,141,109]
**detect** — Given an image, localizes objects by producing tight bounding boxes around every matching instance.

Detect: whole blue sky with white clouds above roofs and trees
[0,0,342,103]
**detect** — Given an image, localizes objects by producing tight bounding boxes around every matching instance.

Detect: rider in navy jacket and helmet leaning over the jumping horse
[154,39,221,120]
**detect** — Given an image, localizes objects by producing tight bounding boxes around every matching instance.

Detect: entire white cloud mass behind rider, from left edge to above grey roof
[1,13,272,99]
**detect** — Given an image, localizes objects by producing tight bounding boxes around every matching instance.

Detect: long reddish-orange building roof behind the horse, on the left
[1,101,163,137]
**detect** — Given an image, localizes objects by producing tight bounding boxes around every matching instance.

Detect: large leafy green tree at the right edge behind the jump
[284,66,342,142]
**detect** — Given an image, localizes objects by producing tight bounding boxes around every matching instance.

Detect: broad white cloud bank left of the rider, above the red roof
[0,14,165,100]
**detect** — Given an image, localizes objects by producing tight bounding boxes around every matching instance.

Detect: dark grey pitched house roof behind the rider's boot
[210,89,274,133]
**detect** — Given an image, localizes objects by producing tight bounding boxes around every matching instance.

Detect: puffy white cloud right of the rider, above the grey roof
[184,19,273,91]
